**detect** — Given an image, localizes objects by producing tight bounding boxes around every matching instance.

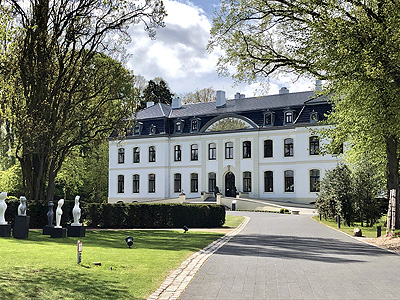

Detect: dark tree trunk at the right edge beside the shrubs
[386,136,400,229]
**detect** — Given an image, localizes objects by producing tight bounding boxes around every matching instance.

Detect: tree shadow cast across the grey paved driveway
[212,234,395,263]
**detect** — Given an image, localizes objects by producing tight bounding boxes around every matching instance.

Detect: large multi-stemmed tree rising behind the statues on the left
[1,0,165,200]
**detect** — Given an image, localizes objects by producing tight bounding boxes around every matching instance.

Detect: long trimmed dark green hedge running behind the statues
[5,199,225,228]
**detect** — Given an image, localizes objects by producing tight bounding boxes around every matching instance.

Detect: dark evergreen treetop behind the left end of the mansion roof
[138,78,174,109]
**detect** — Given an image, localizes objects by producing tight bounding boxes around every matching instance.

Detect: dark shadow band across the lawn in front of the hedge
[15,230,223,251]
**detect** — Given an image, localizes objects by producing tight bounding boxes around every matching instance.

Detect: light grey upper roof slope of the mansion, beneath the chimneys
[137,91,322,120]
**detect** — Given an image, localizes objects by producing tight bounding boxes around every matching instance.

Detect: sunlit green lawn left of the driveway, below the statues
[0,230,222,300]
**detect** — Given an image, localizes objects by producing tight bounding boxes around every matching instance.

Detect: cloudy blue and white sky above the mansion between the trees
[126,0,314,99]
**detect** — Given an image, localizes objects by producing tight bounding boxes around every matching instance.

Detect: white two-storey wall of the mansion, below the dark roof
[109,126,338,203]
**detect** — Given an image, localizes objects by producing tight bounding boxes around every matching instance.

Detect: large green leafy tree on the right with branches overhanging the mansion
[208,0,400,228]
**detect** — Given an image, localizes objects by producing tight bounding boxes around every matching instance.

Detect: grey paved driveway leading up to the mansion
[179,212,400,300]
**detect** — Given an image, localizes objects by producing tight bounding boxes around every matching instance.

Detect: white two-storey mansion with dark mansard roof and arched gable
[108,88,338,203]
